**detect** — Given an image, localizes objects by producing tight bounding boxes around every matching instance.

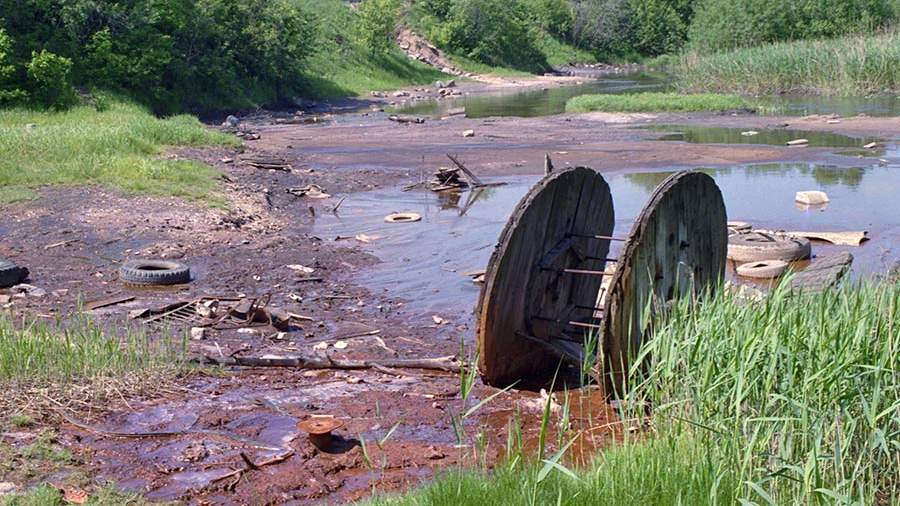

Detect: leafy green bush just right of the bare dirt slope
[431,0,549,72]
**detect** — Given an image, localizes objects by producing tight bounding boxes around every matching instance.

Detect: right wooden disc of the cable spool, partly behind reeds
[602,171,728,395]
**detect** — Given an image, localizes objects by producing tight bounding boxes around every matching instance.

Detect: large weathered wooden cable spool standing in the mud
[476,167,727,393]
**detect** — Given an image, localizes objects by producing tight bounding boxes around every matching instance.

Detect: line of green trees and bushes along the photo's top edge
[0,0,900,113]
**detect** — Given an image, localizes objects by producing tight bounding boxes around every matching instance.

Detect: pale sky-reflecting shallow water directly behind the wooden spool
[316,156,900,322]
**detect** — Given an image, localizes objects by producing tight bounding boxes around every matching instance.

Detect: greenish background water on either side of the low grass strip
[391,72,900,118]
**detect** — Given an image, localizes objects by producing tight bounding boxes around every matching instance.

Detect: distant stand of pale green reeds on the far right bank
[669,30,900,96]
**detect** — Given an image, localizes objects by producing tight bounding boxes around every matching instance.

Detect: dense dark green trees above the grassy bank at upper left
[0,0,315,112]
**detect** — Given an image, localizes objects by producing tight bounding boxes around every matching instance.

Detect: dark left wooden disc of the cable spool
[475,167,615,386]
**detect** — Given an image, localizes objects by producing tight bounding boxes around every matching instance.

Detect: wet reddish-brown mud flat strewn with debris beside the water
[0,78,900,504]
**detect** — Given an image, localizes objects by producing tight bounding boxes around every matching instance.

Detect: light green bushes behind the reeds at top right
[689,0,898,52]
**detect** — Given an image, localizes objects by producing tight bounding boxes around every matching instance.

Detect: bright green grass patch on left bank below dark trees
[0,101,237,205]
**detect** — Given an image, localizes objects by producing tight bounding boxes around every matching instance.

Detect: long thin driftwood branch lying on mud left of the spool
[195,355,461,372]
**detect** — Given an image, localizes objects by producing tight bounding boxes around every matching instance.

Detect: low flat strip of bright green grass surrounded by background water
[566,92,758,112]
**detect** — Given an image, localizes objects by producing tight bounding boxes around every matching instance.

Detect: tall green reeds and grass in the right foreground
[374,282,900,505]
